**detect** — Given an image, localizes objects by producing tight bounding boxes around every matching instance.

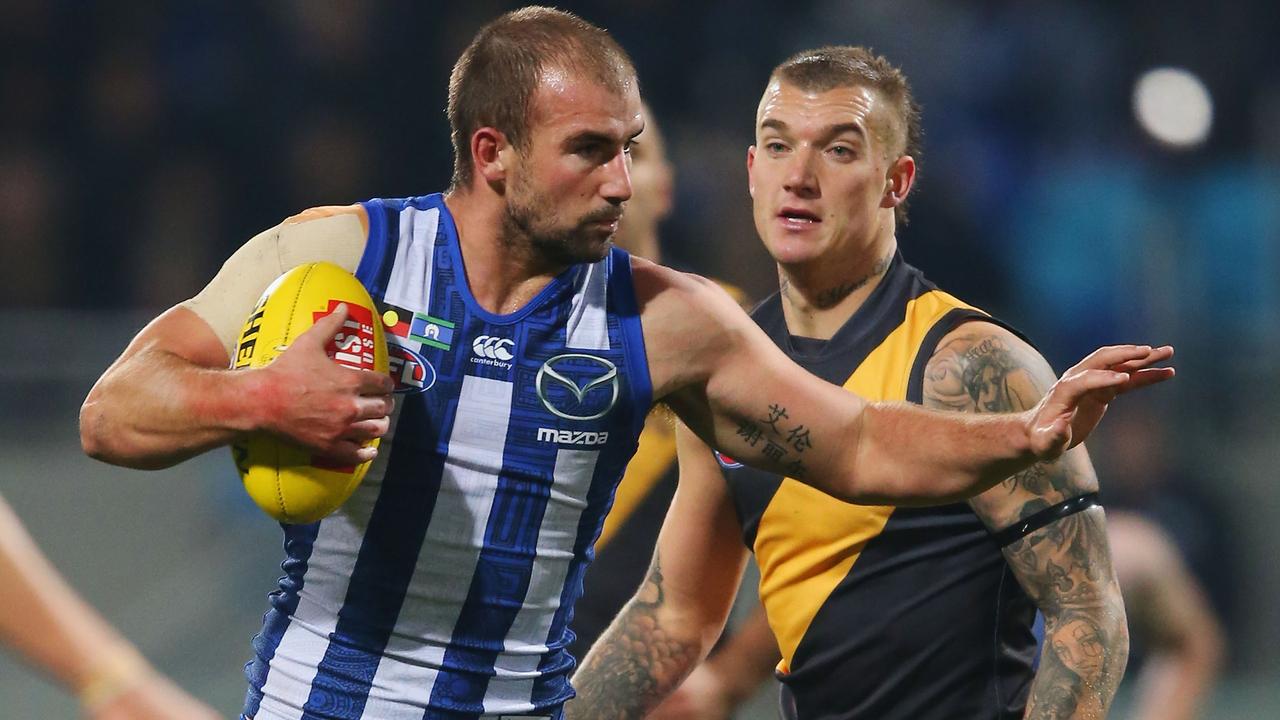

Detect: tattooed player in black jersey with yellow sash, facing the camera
[570,47,1128,720]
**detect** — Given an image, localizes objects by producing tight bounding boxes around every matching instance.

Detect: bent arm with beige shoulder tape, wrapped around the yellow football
[81,206,367,469]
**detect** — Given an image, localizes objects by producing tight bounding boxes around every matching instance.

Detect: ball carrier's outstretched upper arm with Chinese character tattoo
[641,266,867,497]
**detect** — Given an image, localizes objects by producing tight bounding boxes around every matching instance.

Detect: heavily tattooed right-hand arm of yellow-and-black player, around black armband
[924,323,1129,719]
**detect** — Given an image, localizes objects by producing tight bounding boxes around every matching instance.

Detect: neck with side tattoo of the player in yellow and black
[778,241,897,340]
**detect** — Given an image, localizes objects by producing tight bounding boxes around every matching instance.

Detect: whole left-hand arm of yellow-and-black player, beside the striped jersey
[566,425,746,720]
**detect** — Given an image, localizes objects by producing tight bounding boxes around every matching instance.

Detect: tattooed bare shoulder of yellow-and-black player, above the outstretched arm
[923,319,1056,413]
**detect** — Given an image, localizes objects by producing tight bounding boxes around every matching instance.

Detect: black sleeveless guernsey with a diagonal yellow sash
[718,255,1036,720]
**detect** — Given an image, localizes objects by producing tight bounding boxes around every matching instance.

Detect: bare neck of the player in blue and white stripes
[444,190,564,315]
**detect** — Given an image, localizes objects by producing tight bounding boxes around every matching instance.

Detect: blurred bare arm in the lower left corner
[0,498,218,720]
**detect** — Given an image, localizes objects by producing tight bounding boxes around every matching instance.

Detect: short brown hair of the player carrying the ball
[448,6,635,188]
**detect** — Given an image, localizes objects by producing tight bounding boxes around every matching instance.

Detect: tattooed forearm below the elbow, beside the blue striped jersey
[564,555,701,720]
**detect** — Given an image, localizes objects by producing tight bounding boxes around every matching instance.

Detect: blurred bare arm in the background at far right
[1108,512,1226,720]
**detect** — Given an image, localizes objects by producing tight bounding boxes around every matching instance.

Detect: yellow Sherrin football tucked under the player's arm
[232,263,387,524]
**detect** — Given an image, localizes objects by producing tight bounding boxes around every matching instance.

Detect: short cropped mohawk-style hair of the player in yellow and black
[769,45,924,224]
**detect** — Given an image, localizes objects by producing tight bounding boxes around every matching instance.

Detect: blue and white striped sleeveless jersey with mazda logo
[244,195,652,720]
